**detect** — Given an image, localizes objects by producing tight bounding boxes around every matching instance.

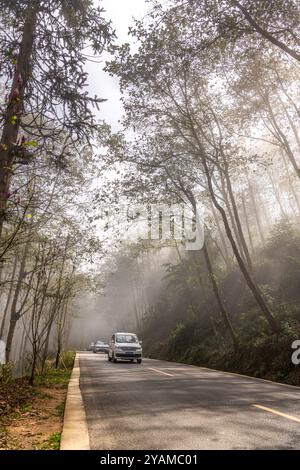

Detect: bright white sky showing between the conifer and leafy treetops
[86,0,147,131]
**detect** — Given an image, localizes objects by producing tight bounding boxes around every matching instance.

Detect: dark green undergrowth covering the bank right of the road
[143,225,300,385]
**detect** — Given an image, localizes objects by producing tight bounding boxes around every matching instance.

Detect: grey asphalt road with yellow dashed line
[80,353,300,450]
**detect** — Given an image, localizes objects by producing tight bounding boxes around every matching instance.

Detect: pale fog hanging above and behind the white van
[68,247,176,349]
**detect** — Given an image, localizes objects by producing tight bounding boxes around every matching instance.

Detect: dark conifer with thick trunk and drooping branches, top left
[0,0,112,232]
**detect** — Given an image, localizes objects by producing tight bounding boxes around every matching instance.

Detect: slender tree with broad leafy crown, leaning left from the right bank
[108,1,280,332]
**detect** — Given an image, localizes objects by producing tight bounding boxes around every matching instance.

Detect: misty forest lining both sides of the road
[0,0,300,408]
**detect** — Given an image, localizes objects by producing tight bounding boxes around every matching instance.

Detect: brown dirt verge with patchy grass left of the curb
[0,351,76,450]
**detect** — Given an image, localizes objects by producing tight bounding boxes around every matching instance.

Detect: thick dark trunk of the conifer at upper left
[0,2,37,237]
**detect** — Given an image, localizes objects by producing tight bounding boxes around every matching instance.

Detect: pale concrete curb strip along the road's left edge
[60,354,90,450]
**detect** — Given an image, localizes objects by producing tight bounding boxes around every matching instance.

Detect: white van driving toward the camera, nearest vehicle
[108,333,143,364]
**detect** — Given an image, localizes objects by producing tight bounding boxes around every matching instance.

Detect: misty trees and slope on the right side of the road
[97,0,300,384]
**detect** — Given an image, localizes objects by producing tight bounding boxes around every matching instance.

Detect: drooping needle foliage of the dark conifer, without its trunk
[0,0,114,140]
